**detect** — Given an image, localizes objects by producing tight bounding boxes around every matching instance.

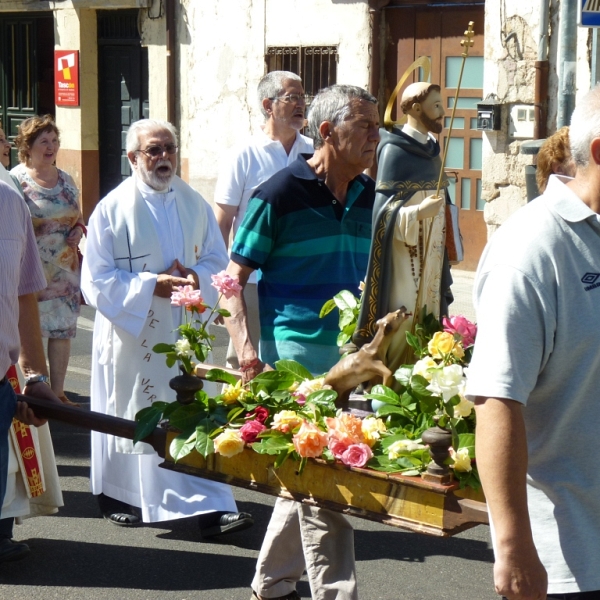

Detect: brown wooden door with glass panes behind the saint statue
[385,4,487,270]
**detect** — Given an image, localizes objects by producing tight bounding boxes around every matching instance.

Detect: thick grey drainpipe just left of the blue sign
[556,0,577,129]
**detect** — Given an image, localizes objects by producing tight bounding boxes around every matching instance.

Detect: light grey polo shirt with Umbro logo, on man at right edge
[467,176,600,594]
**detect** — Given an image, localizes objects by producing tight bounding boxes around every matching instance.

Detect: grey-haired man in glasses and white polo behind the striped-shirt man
[215,71,313,369]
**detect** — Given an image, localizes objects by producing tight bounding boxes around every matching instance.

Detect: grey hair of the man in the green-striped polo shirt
[308,85,377,150]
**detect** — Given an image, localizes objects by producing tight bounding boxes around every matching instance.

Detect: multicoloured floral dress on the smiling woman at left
[11,164,81,339]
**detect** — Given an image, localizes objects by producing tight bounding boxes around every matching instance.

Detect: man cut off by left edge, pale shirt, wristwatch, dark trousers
[0,178,60,563]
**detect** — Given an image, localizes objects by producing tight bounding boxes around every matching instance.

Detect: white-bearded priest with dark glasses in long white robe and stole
[81,119,253,537]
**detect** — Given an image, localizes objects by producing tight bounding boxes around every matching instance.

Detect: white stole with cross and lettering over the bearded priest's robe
[100,178,208,454]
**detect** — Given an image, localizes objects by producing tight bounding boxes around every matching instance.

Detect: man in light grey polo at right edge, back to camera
[467,88,600,600]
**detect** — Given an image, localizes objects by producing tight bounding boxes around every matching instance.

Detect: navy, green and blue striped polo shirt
[231,155,375,374]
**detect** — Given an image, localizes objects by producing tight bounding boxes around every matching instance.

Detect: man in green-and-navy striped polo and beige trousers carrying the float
[226,85,379,600]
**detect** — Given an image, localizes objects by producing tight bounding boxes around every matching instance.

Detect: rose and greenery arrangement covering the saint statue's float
[134,273,479,488]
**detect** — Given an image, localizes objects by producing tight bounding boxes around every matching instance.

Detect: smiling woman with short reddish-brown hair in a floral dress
[11,115,85,404]
